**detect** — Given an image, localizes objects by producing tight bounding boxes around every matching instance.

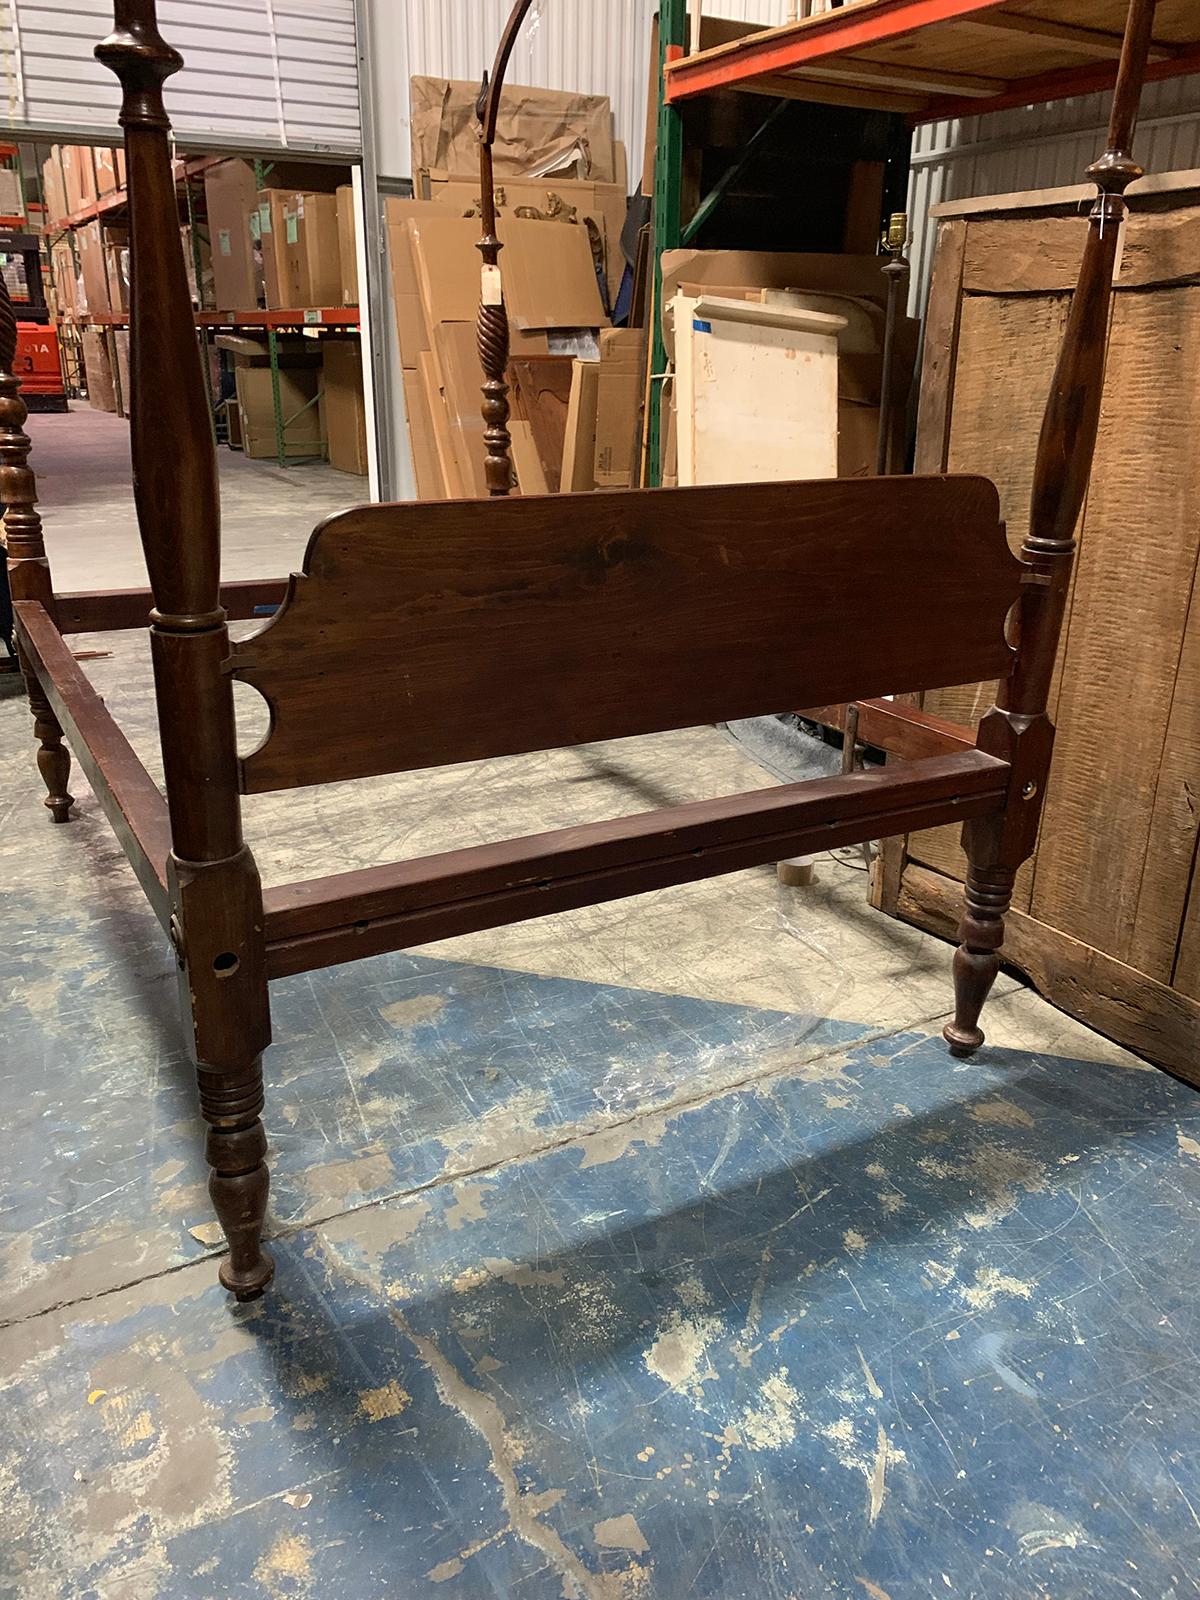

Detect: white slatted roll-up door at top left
[0,0,360,154]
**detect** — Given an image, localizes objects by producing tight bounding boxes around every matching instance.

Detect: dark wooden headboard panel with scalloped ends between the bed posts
[230,477,1021,794]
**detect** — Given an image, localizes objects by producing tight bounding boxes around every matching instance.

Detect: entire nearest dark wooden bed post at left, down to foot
[96,0,274,1299]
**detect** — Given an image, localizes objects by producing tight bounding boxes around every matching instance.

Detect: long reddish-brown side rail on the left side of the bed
[13,600,171,926]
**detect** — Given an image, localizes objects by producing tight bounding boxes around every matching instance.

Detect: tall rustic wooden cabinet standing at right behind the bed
[878,173,1200,1082]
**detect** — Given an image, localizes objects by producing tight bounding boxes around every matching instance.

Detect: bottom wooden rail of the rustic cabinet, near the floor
[898,866,1200,1085]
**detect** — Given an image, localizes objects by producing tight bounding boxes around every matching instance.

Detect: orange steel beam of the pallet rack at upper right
[666,0,1005,101]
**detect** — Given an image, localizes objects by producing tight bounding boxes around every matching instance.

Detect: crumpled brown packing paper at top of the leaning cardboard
[411,77,618,184]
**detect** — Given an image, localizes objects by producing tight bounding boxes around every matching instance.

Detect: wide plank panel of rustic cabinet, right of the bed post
[1030,288,1200,978]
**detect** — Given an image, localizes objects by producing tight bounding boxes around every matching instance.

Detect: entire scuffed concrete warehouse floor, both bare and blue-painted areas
[0,411,1200,1600]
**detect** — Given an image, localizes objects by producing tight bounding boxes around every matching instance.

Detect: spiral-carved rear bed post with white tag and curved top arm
[475,0,533,494]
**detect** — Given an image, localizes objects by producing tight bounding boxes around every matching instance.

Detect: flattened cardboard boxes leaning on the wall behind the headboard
[396,78,642,499]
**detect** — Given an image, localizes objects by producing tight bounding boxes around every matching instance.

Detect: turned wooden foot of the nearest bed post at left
[197,1058,275,1301]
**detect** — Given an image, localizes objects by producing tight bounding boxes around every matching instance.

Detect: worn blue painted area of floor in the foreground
[0,934,1200,1600]
